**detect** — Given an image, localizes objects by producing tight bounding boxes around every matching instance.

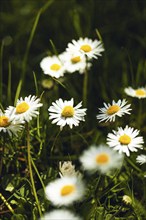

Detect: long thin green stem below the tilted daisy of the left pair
[26,124,42,217]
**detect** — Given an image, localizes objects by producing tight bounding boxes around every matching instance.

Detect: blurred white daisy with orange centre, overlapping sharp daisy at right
[80,145,123,174]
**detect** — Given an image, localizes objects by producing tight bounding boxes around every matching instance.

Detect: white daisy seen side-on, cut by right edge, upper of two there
[124,87,146,99]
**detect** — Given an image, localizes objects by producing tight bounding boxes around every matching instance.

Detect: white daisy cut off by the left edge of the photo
[0,109,23,136]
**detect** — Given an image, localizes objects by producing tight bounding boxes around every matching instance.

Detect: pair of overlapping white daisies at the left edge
[0,95,43,136]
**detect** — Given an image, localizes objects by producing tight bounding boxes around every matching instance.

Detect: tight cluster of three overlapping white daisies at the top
[40,38,104,78]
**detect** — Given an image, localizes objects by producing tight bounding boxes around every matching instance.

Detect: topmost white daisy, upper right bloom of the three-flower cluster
[66,38,104,60]
